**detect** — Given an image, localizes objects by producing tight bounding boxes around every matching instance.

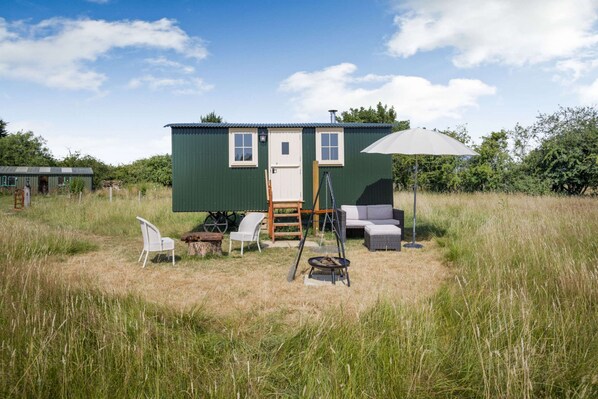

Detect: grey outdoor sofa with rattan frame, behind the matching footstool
[338,205,405,242]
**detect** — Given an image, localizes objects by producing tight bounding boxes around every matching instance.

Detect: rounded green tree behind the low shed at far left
[0,132,56,166]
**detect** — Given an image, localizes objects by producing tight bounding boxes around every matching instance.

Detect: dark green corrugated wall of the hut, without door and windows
[172,127,393,212]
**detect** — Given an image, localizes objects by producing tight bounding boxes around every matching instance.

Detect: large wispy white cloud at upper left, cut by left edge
[0,18,207,91]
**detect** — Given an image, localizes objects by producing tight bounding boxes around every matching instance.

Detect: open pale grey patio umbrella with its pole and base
[361,127,478,248]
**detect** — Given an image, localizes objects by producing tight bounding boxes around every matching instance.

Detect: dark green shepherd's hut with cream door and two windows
[166,123,393,239]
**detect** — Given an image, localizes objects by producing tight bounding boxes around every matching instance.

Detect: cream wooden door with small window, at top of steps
[268,129,303,201]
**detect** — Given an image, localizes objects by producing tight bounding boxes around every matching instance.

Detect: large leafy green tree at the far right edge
[523,107,598,195]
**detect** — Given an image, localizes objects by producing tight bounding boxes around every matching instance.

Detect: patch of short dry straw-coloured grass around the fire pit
[55,233,449,322]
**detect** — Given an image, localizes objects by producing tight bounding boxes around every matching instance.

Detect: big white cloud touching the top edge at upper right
[387,0,598,67]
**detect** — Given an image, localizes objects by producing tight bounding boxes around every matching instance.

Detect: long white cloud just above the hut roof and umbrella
[280,63,496,125]
